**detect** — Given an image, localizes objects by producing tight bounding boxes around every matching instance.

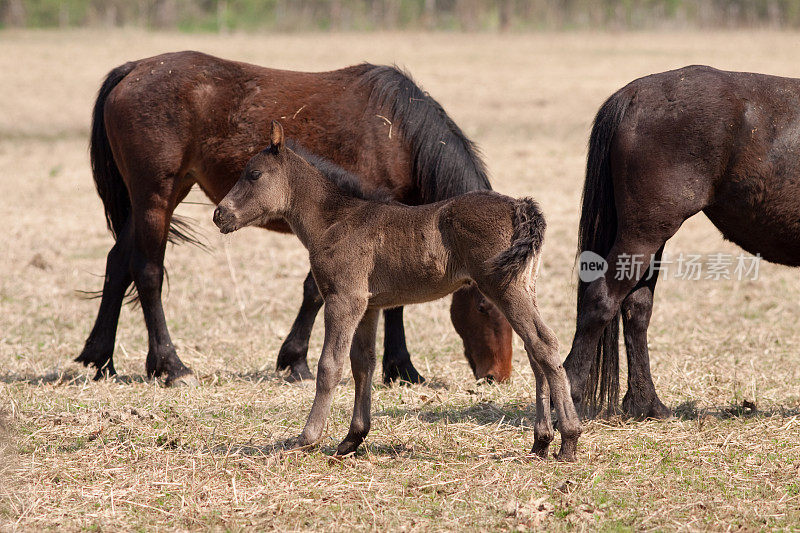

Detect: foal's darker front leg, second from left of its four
[336,309,380,455]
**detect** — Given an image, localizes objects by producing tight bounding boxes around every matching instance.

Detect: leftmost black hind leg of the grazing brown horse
[75,220,133,380]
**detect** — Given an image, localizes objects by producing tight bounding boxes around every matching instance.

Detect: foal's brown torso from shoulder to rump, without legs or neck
[312,191,514,307]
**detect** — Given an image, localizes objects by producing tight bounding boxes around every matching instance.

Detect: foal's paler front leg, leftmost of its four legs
[298,294,367,446]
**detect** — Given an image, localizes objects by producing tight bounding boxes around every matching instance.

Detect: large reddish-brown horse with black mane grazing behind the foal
[77,52,511,384]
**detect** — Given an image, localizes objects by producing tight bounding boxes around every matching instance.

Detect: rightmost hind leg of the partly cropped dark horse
[622,246,672,418]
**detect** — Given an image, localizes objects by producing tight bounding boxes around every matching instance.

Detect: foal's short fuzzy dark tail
[490,198,547,283]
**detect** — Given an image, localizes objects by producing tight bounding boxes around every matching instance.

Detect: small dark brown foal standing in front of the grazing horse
[214,122,581,461]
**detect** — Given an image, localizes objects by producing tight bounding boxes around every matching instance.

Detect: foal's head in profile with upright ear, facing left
[214,121,289,233]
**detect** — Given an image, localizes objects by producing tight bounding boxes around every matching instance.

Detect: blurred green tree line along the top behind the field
[0,0,800,32]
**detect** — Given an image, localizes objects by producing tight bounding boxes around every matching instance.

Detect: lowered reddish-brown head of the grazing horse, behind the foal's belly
[450,284,512,381]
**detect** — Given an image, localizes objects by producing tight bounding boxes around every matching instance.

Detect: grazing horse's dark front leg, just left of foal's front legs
[276,271,324,381]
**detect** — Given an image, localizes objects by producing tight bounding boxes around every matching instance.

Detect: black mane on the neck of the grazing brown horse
[361,63,492,203]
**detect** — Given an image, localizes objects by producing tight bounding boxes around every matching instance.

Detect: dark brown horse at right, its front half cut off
[564,66,800,418]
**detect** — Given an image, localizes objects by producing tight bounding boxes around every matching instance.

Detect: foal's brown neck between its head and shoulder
[284,157,366,249]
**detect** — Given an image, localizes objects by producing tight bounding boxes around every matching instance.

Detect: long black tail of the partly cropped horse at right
[578,91,631,416]
